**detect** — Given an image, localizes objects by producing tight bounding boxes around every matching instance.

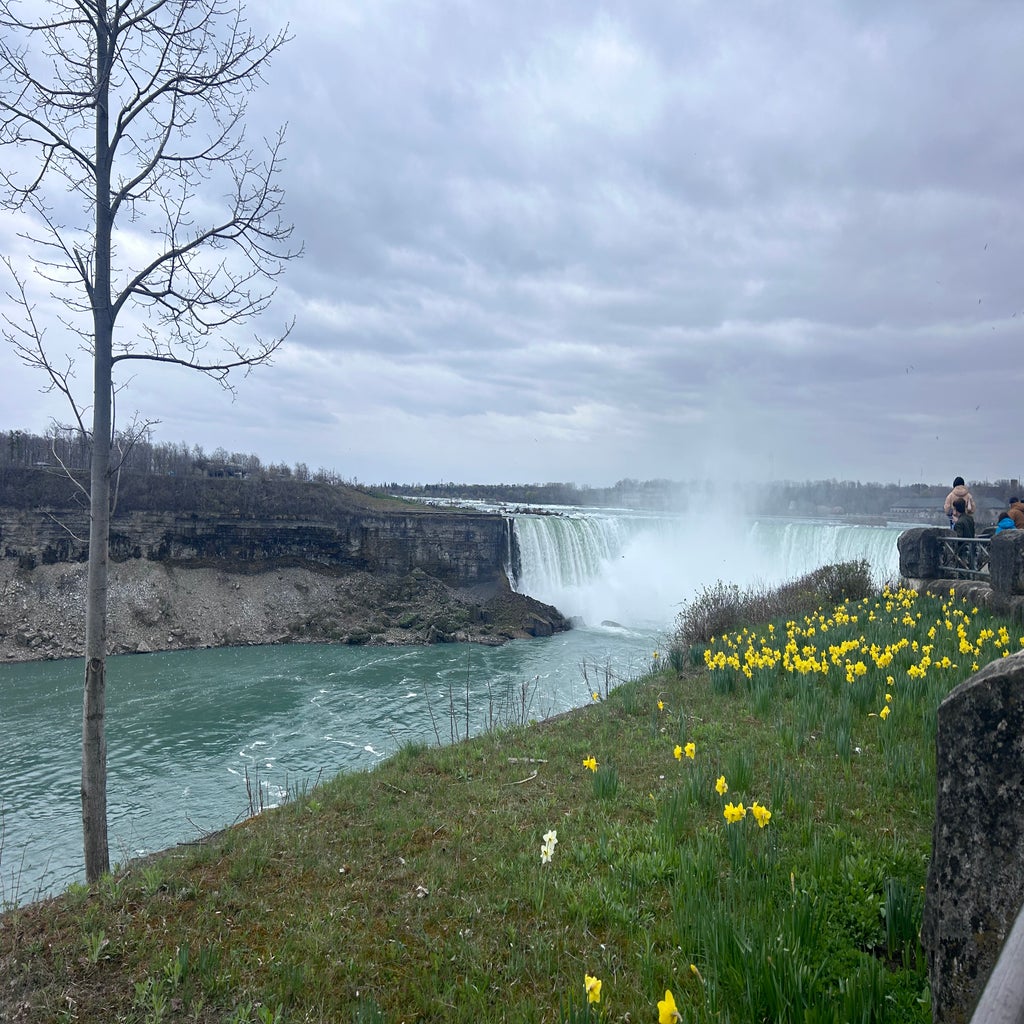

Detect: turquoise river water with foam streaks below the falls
[0,628,664,903]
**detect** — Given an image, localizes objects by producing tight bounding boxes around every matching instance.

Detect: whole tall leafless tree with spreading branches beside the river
[0,0,299,882]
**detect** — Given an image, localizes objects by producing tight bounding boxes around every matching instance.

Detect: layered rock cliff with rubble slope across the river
[0,501,568,660]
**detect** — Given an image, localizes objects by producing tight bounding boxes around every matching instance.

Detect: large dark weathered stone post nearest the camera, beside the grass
[922,651,1024,1024]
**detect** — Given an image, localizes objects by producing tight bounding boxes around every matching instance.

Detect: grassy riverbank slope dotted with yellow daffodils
[0,581,1020,1024]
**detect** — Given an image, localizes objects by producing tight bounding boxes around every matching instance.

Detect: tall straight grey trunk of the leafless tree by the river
[82,0,114,882]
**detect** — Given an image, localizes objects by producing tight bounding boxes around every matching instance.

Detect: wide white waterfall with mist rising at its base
[510,509,902,628]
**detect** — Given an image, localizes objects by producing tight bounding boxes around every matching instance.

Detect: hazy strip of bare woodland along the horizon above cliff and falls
[0,428,1020,517]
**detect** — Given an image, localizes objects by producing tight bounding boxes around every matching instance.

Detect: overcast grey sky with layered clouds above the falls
[0,0,1024,485]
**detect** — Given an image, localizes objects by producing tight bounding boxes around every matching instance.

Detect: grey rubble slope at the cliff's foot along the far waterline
[0,558,569,663]
